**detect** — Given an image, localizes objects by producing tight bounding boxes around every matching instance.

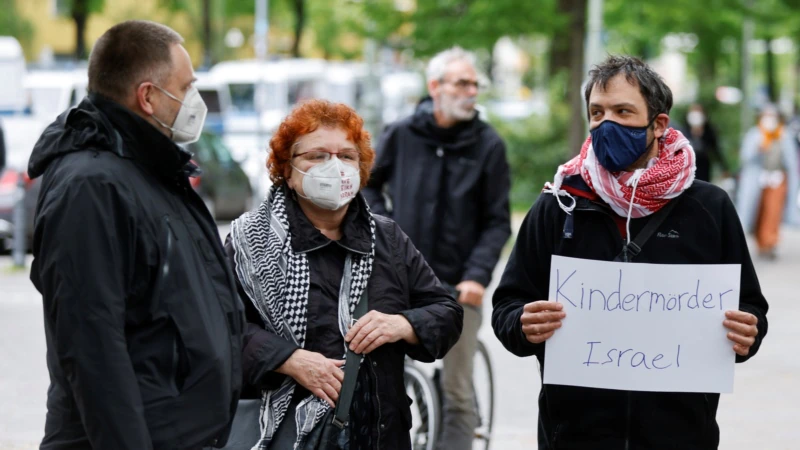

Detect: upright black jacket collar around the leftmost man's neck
[89,94,192,179]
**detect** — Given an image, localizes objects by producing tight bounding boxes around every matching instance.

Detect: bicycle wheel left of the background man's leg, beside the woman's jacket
[403,363,441,450]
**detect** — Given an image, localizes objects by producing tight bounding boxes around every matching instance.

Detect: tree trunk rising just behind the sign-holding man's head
[559,0,587,154]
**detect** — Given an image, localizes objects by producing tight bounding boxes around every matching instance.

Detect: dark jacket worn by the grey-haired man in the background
[364,98,511,286]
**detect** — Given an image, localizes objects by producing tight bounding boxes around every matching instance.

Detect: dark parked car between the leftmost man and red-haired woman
[187,132,252,220]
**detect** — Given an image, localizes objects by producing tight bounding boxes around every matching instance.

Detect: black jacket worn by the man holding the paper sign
[492,181,768,450]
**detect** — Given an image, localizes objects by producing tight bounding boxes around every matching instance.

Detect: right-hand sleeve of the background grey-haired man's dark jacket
[462,138,511,287]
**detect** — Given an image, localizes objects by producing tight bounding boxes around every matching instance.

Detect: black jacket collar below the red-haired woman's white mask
[283,186,372,255]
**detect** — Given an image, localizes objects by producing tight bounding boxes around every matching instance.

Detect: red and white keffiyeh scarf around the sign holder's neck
[544,128,695,219]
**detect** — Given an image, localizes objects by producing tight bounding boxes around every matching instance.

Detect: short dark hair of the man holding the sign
[584,56,672,121]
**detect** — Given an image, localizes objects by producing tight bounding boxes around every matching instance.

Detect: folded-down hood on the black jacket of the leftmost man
[28,97,122,178]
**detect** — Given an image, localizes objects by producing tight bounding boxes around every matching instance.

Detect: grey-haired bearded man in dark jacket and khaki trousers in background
[364,47,511,450]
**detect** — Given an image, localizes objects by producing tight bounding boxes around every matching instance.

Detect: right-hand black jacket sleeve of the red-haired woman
[393,224,464,362]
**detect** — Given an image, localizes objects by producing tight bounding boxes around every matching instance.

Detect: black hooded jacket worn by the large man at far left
[28,95,244,450]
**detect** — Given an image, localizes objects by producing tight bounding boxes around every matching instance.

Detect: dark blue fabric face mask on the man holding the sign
[591,116,658,172]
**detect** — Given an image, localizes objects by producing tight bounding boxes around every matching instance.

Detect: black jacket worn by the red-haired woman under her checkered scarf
[225,190,464,450]
